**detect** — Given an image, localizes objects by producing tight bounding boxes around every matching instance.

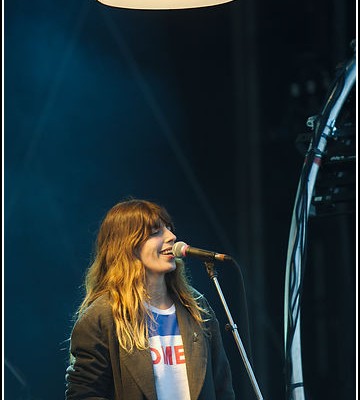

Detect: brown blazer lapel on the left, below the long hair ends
[120,349,157,400]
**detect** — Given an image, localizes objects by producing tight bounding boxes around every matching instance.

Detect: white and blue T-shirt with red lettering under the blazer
[149,304,190,400]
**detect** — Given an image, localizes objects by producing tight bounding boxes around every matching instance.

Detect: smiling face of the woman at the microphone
[139,225,176,275]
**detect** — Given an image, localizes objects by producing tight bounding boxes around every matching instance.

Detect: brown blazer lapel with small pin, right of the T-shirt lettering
[176,303,208,400]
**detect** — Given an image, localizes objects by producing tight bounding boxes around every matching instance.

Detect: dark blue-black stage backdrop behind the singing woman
[3,0,356,400]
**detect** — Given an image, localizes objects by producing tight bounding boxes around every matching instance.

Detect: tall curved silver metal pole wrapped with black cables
[284,50,356,400]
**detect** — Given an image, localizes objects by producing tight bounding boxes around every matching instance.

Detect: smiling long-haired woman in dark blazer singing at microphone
[66,200,235,400]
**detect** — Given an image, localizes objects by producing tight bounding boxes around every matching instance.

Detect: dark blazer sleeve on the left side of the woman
[65,306,114,400]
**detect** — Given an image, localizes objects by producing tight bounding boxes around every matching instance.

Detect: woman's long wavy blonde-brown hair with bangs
[77,199,207,352]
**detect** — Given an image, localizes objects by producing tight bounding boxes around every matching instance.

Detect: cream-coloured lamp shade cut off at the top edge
[98,0,232,10]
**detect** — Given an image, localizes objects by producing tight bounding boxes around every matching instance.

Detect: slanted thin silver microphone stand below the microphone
[205,261,263,400]
